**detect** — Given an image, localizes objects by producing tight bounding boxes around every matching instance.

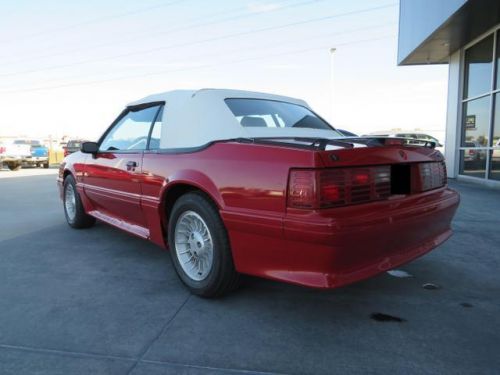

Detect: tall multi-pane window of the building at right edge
[459,29,500,181]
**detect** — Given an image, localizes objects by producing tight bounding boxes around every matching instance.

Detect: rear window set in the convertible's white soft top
[225,98,340,136]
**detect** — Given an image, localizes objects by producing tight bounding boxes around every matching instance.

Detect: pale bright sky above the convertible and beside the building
[0,0,448,139]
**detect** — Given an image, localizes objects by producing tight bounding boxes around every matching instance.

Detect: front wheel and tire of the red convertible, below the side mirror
[63,175,95,229]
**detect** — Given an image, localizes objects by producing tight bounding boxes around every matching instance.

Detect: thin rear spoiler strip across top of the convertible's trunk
[234,136,436,151]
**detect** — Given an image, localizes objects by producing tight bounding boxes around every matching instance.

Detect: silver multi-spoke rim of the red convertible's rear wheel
[174,211,214,281]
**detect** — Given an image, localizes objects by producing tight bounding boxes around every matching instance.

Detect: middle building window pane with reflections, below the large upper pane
[462,96,490,147]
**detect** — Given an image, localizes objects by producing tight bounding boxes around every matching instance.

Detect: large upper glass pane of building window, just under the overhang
[464,35,493,98]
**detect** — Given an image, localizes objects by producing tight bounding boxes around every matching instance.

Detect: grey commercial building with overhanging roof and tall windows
[398,0,500,187]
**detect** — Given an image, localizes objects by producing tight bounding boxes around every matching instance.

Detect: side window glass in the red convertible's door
[99,106,159,151]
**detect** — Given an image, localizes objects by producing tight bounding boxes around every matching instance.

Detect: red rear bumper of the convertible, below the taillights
[222,188,460,288]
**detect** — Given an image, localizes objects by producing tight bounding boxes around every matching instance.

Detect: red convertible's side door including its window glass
[83,103,162,234]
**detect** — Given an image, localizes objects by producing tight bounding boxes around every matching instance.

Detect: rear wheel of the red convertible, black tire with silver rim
[168,192,239,298]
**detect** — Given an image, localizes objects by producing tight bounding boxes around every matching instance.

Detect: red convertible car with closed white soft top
[58,89,459,297]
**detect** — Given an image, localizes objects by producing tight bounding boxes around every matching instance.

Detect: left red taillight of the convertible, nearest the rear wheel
[288,166,391,209]
